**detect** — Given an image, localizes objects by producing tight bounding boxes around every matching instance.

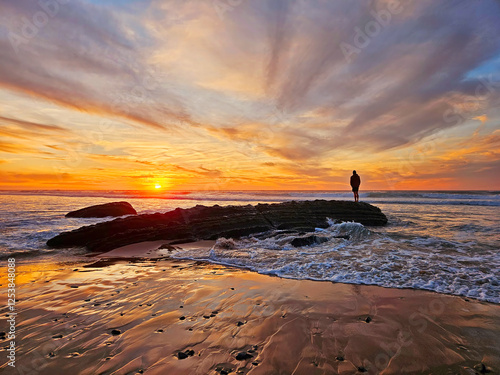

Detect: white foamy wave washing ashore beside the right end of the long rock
[168,222,500,303]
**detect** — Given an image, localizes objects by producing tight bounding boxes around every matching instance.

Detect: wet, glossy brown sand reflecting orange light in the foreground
[0,253,500,375]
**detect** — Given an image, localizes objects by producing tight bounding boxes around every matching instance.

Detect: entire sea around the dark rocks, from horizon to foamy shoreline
[0,191,500,303]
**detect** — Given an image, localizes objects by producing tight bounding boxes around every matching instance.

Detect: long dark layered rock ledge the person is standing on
[47,200,387,251]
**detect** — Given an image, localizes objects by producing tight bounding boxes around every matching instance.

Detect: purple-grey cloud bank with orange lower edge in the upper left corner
[0,0,191,129]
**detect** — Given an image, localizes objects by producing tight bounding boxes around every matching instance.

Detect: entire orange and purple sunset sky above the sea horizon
[0,0,500,191]
